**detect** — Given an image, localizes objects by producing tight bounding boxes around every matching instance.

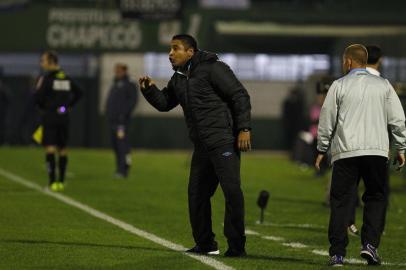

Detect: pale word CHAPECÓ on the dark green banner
[47,22,142,49]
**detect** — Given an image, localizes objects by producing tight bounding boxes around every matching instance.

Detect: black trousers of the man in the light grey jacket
[328,156,388,256]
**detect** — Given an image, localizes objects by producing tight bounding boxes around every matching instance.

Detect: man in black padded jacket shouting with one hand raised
[140,35,251,257]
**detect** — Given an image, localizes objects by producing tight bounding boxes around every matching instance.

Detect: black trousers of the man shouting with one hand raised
[188,144,245,251]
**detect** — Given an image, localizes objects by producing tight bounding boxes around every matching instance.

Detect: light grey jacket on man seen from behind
[317,69,406,163]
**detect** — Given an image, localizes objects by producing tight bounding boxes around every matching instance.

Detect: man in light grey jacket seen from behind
[315,44,406,266]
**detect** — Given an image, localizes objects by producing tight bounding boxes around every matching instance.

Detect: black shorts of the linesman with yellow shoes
[42,122,69,148]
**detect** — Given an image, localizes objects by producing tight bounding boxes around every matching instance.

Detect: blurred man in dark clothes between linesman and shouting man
[106,63,137,178]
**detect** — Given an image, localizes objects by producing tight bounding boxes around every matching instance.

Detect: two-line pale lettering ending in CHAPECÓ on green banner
[47,8,142,49]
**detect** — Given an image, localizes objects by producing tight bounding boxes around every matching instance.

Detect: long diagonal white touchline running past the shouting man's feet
[0,168,234,270]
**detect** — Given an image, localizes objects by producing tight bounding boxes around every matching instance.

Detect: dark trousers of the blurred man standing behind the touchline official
[110,125,131,176]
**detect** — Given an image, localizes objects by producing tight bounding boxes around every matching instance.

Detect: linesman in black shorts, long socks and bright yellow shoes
[35,51,82,191]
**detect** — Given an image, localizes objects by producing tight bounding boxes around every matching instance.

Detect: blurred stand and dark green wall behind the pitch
[0,0,406,153]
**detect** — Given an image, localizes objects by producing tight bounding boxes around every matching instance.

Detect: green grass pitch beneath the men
[0,147,406,270]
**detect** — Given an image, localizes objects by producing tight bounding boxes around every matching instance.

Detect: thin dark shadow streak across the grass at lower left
[0,239,172,252]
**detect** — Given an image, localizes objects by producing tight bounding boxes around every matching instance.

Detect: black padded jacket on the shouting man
[142,51,251,150]
